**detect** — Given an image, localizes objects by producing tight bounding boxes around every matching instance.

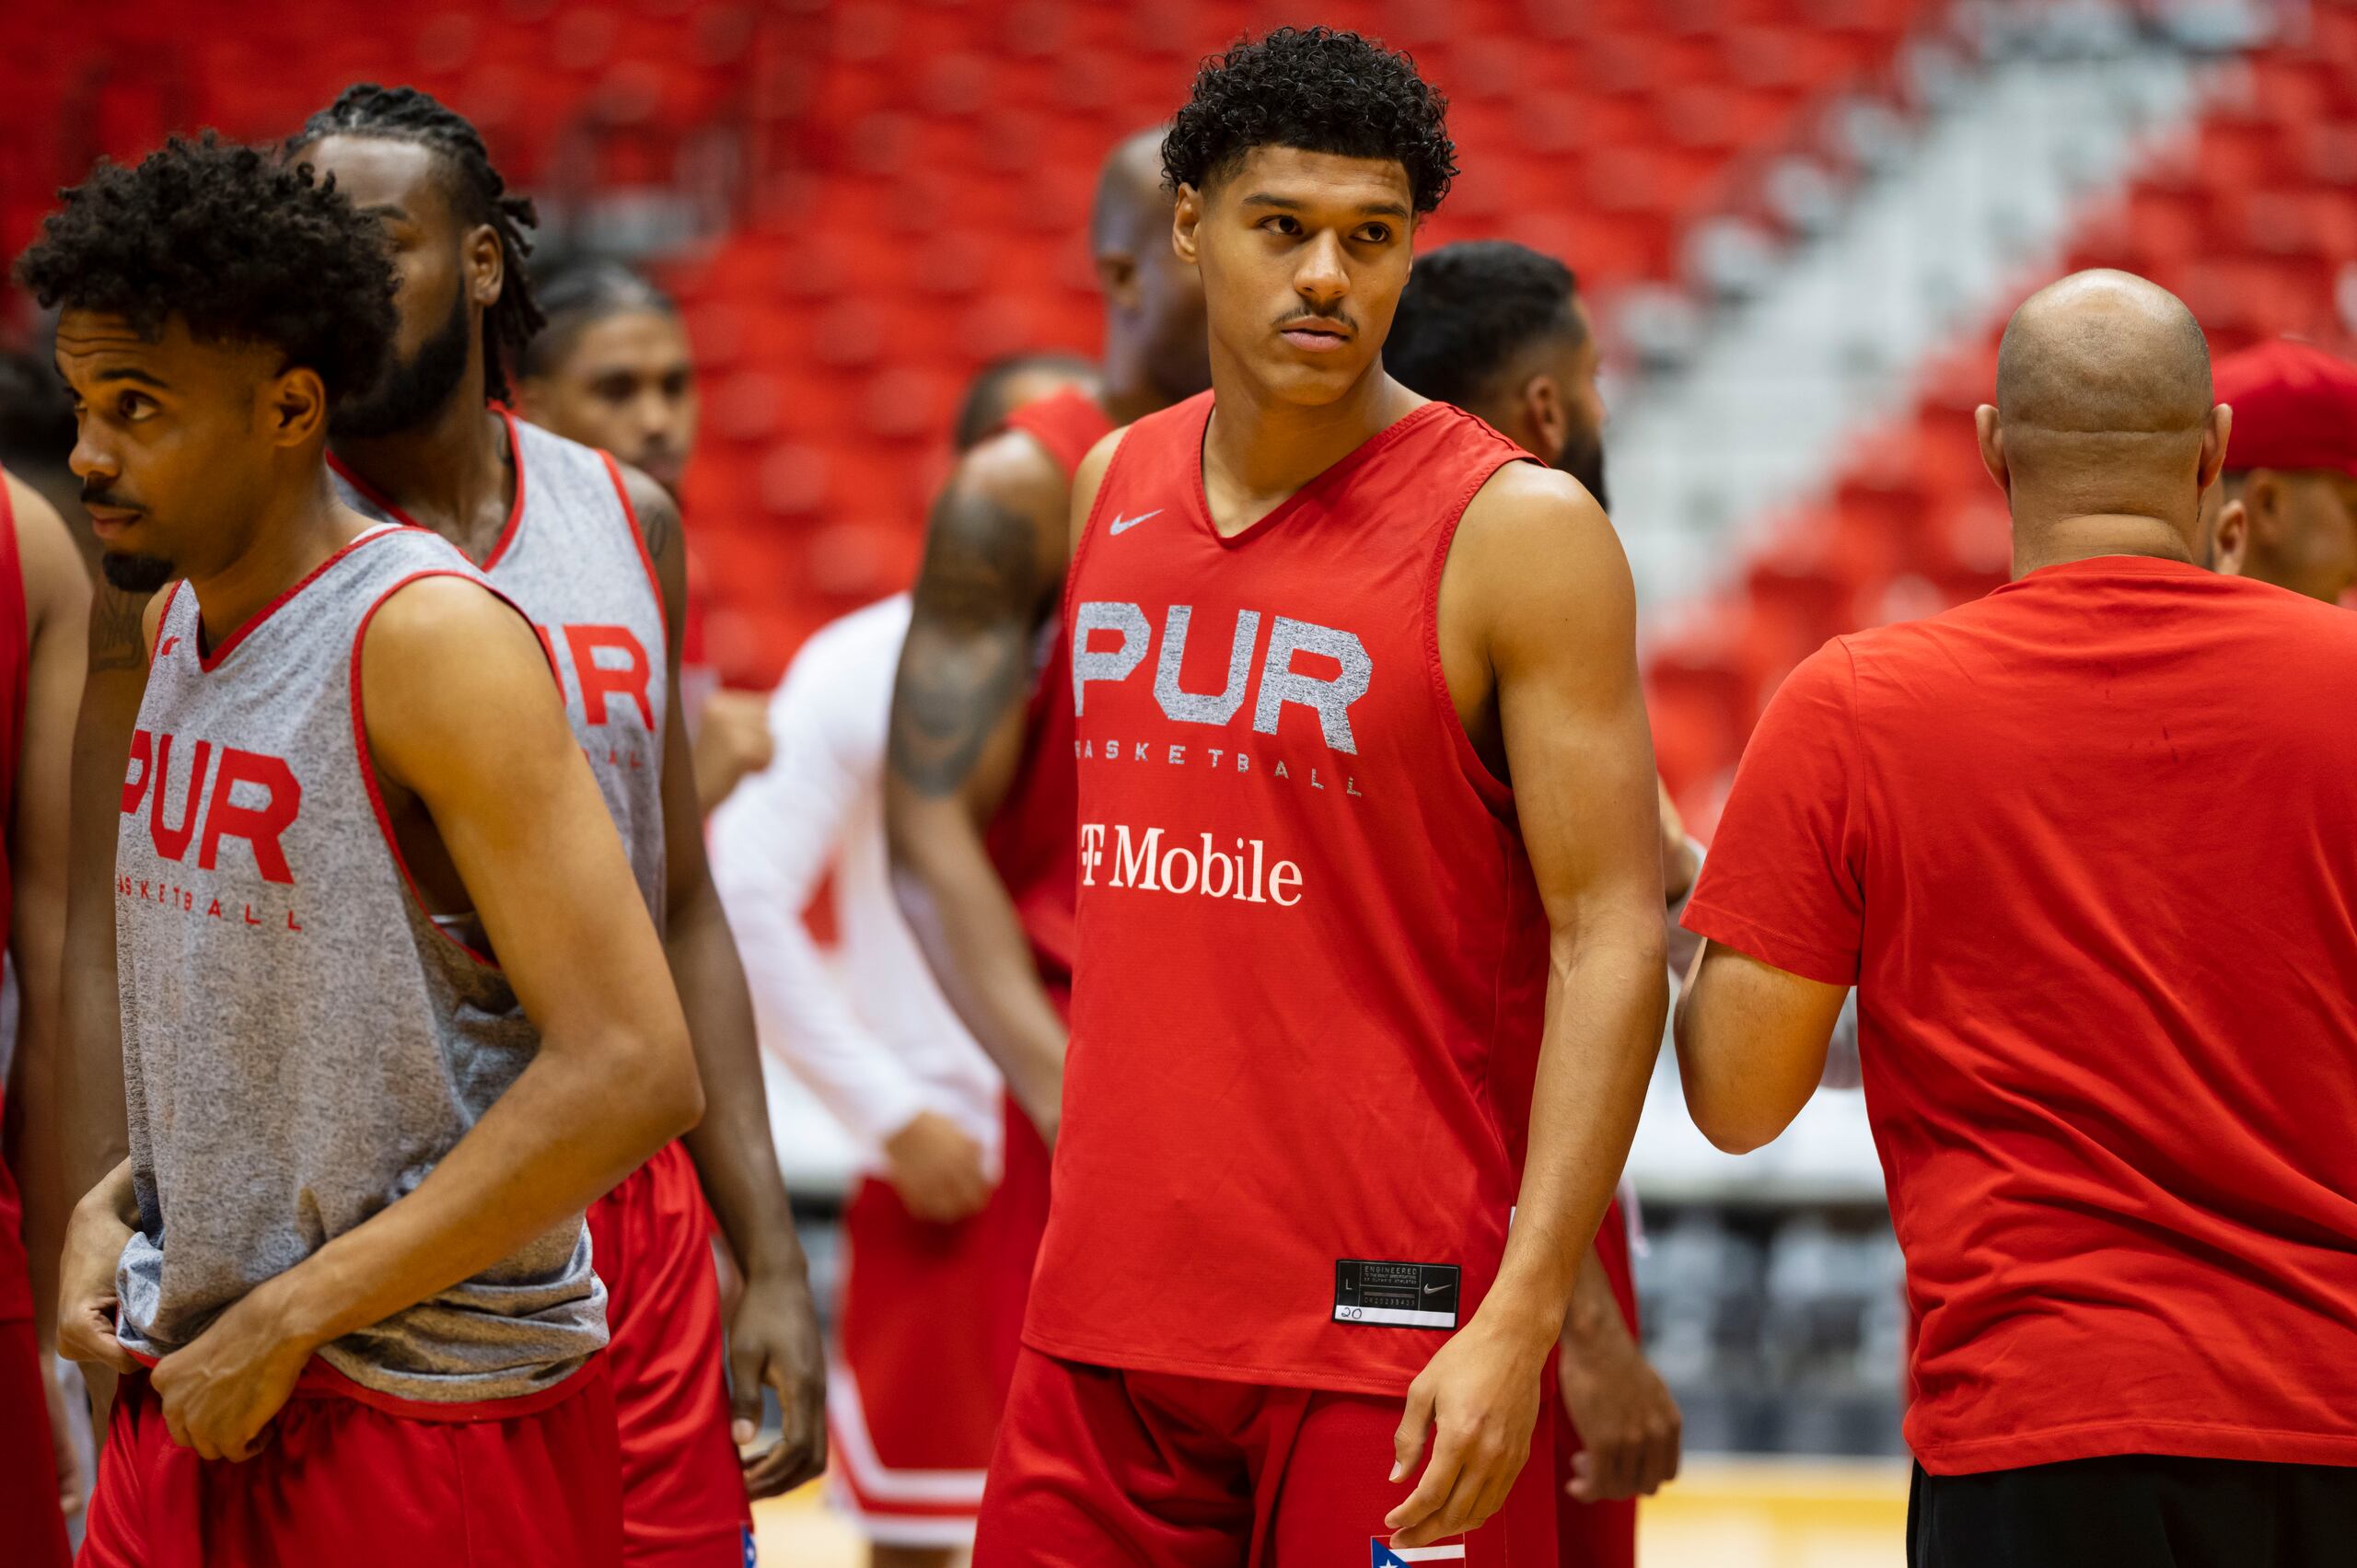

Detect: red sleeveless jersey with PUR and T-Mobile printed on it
[1026,394,1546,1396]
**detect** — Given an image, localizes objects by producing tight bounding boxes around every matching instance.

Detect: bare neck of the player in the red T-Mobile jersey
[1202,349,1423,528]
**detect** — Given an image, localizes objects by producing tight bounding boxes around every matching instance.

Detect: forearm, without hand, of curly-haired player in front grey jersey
[261,1028,683,1346]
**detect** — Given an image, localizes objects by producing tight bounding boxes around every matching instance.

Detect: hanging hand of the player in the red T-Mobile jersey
[1384,1311,1546,1547]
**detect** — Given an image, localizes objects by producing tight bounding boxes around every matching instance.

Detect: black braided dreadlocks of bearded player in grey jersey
[285,83,547,403]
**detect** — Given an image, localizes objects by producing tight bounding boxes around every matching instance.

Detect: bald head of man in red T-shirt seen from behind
[1980,269,2225,563]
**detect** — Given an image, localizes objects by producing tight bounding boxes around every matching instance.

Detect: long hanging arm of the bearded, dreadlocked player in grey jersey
[622,470,828,1497]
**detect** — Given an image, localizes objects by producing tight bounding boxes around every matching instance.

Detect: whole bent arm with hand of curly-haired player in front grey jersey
[156,577,702,1458]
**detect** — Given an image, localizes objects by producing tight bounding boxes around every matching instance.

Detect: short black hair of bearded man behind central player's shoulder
[1384,240,1579,408]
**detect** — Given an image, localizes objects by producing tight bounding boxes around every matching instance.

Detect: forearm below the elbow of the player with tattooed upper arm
[893,799,1065,1127]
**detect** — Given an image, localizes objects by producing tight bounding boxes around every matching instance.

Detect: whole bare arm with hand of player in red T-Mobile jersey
[1390,464,1668,1544]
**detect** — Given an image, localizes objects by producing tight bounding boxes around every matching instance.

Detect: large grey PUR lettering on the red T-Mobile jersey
[1073,598,1374,752]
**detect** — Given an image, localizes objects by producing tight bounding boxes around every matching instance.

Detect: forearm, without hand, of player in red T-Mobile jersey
[1482,922,1668,1340]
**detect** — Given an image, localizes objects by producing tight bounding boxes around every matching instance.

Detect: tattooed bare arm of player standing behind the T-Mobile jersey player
[884,434,1065,1136]
